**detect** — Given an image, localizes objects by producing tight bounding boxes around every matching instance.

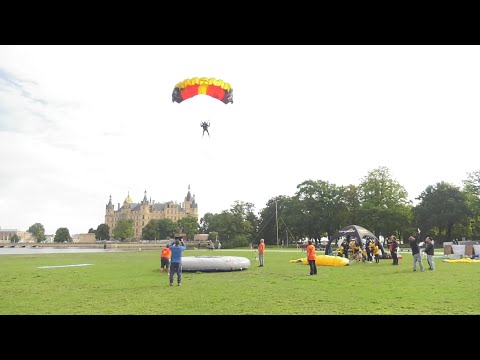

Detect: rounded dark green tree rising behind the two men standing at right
[414,181,472,242]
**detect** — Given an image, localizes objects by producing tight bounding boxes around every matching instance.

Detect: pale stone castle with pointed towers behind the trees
[105,185,198,240]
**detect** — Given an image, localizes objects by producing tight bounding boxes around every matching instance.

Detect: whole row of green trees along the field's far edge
[21,166,480,248]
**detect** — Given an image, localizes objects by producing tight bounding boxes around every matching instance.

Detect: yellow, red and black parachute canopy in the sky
[172,77,233,104]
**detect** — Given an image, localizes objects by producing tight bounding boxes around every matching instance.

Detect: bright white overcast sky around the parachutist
[0,45,480,235]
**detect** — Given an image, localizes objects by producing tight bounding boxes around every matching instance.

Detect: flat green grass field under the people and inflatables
[0,247,480,315]
